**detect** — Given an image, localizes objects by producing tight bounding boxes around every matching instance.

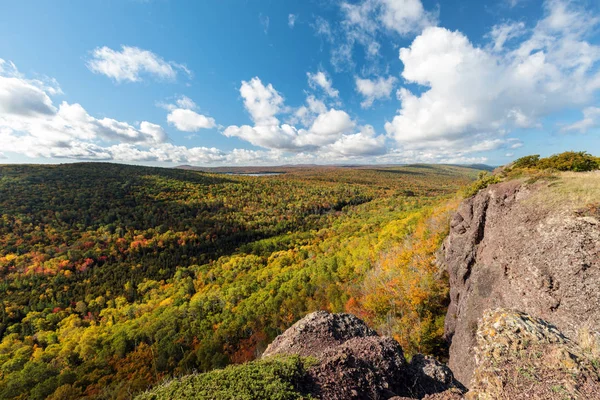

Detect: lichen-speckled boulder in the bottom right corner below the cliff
[466,309,600,400]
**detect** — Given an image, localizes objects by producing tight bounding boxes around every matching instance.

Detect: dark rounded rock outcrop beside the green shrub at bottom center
[263,311,462,400]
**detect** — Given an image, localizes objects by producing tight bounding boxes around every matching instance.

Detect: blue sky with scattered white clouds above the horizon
[0,0,600,166]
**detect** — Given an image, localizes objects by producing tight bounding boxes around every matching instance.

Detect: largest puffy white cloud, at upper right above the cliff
[385,0,600,153]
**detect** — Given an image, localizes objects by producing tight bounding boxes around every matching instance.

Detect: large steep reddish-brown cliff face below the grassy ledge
[441,181,600,386]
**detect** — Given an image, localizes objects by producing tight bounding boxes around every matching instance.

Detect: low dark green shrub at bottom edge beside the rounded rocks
[136,356,316,400]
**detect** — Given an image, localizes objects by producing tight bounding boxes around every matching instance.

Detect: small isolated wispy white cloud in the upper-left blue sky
[87,46,191,82]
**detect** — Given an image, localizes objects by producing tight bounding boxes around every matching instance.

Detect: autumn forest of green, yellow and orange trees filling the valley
[0,163,480,399]
